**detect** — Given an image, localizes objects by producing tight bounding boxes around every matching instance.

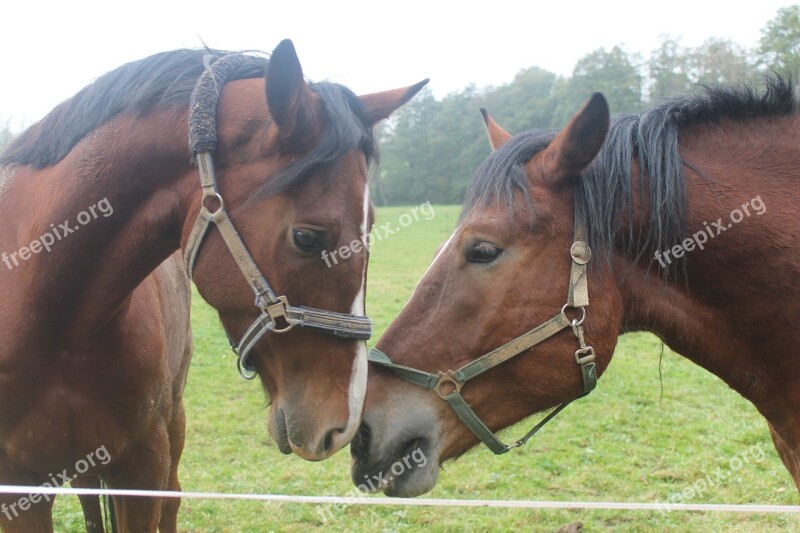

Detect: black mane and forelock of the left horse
[0,48,378,194]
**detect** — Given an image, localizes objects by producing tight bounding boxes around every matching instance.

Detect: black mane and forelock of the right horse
[461,76,798,259]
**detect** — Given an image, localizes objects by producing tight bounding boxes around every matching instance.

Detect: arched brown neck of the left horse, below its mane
[0,110,199,339]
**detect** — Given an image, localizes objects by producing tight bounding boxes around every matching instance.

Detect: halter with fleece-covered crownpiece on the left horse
[184,54,372,380]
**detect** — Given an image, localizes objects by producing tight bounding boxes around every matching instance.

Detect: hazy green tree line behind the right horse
[372,5,800,204]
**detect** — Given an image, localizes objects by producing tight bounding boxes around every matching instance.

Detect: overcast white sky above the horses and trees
[0,0,795,125]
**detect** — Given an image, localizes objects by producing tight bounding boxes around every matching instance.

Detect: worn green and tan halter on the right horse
[367,200,597,455]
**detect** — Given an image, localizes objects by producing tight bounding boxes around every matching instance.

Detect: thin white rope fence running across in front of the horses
[0,485,800,514]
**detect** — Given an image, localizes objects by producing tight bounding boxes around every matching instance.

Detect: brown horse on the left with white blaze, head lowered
[0,41,424,532]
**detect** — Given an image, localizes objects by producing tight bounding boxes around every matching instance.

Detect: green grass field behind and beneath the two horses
[56,206,800,532]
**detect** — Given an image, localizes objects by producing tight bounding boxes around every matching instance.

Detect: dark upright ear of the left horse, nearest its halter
[265,39,316,146]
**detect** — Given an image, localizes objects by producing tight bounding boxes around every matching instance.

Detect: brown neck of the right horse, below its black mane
[615,118,800,418]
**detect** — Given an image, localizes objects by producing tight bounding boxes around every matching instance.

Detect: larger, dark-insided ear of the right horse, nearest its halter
[543,93,610,180]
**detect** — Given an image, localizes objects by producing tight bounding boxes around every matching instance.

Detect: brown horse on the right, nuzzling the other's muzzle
[351,79,800,496]
